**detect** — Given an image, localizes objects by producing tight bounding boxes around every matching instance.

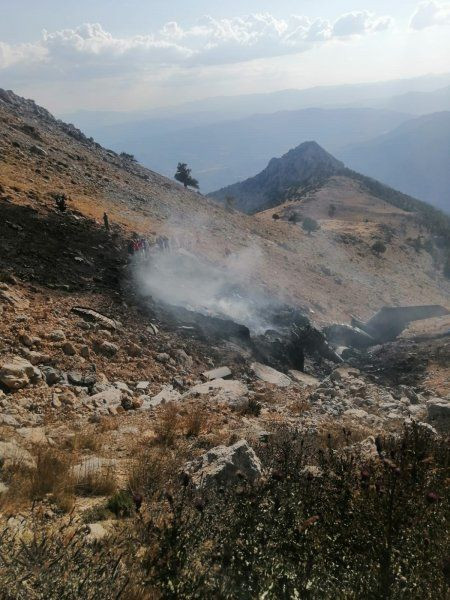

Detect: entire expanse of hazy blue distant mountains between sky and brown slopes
[65,73,450,211]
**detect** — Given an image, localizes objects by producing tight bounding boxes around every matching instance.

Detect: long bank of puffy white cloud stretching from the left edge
[0,11,391,79]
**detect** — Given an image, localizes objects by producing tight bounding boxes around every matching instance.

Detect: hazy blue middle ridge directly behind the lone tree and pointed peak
[76,108,410,192]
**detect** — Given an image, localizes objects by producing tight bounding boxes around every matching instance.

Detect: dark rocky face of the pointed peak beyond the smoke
[211,141,345,213]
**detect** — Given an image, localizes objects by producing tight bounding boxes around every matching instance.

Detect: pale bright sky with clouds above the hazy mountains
[0,0,450,114]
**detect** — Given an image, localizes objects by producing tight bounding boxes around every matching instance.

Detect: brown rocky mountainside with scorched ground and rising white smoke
[0,91,450,599]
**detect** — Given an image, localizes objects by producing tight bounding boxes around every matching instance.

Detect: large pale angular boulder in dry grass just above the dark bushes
[185,440,262,488]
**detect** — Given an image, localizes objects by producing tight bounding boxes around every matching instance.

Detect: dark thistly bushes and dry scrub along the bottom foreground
[0,427,449,600]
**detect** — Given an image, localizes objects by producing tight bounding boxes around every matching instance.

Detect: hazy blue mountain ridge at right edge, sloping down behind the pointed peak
[337,111,450,213]
